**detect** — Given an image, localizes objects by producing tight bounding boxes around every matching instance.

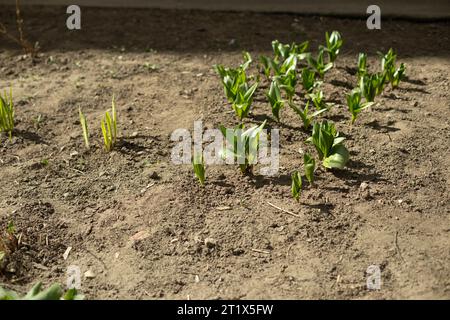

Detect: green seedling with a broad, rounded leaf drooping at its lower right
[306,120,349,169]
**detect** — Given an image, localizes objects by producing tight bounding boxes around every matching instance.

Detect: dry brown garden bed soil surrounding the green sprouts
[0,7,450,299]
